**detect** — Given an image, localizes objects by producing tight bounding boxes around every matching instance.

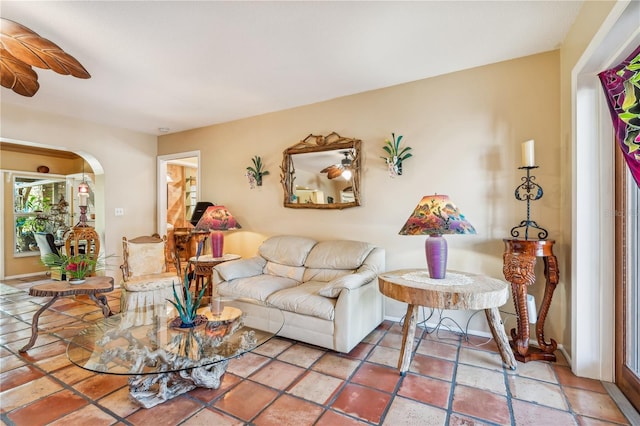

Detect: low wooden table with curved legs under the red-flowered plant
[20,277,113,352]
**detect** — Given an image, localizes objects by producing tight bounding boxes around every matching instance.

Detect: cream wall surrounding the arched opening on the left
[0,104,156,276]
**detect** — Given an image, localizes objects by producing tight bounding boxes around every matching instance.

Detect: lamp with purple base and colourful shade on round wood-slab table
[399,194,476,279]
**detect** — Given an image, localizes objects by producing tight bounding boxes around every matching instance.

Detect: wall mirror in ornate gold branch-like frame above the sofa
[280,132,361,209]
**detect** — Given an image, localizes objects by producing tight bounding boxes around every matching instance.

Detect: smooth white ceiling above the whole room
[0,0,582,135]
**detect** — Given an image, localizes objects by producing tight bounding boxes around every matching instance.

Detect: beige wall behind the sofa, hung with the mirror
[158,51,565,336]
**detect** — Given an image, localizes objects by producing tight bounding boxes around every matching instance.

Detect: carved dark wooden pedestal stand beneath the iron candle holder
[503,239,560,362]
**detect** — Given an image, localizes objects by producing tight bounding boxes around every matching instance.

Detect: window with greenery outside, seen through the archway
[13,175,69,256]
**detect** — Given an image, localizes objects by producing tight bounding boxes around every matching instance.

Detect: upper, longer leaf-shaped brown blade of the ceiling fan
[0,18,91,78]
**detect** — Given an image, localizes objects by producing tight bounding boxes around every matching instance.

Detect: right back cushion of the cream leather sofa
[304,240,374,269]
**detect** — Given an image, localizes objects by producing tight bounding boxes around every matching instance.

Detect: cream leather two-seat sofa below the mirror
[214,235,385,353]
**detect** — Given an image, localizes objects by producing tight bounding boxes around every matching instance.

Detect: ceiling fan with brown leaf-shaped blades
[0,18,91,97]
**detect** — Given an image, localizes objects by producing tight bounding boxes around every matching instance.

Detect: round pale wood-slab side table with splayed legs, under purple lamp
[378,269,516,375]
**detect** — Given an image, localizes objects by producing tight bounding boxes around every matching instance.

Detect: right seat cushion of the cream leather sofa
[267,281,336,321]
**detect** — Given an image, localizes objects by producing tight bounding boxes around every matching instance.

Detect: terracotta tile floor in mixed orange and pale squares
[0,277,630,426]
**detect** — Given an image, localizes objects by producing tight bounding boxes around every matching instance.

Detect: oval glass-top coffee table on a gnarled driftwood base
[67,298,284,408]
